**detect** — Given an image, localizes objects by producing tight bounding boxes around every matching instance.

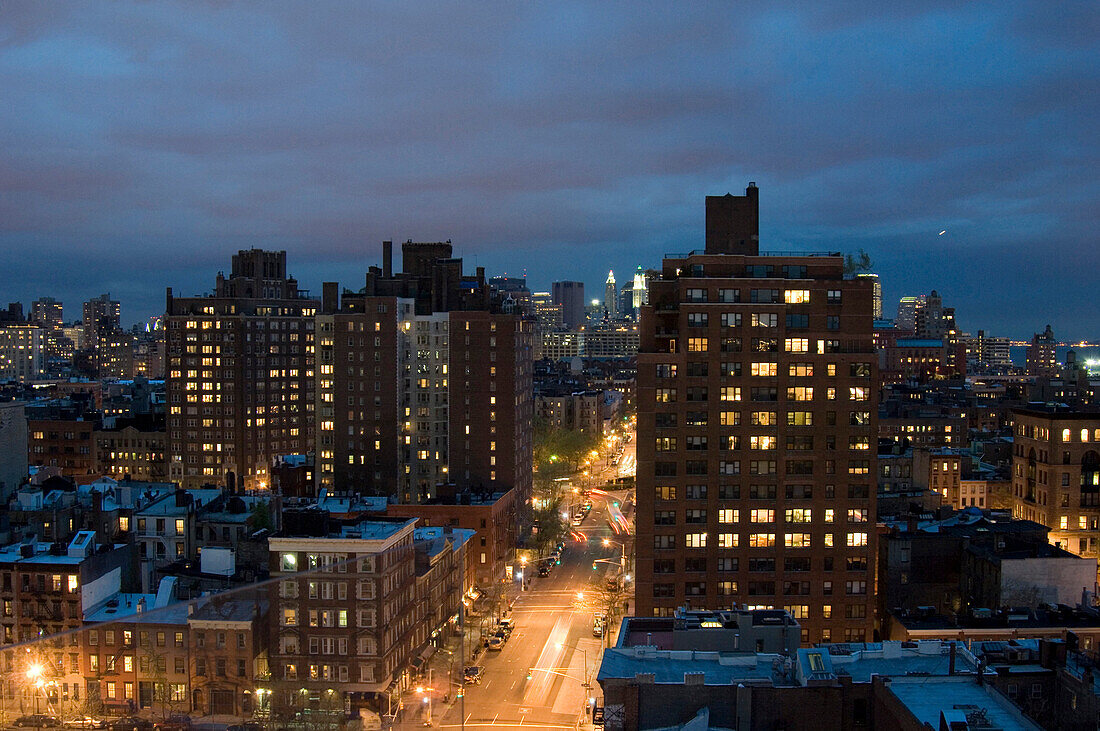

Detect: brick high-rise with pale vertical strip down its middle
[317,242,534,502]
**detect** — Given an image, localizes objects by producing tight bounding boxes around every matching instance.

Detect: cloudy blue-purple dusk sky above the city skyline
[0,0,1100,340]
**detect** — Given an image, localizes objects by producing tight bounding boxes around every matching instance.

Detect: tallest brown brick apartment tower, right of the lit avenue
[636,185,878,642]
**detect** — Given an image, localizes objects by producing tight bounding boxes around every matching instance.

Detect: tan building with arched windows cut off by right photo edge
[1012,403,1100,557]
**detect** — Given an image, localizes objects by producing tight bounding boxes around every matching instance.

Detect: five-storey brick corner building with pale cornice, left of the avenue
[265,513,419,717]
